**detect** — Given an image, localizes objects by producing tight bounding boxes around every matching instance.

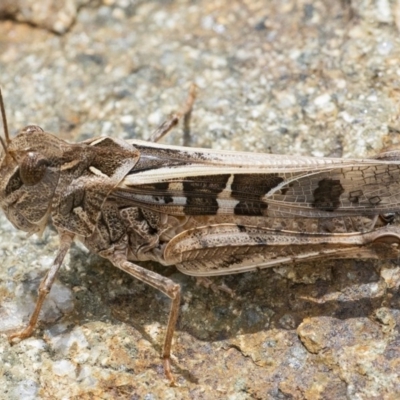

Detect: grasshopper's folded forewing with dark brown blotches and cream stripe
[112,141,400,217]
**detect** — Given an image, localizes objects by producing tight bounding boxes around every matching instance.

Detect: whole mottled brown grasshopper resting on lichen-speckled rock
[0,85,400,384]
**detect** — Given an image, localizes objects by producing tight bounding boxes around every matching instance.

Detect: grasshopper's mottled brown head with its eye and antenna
[0,98,63,234]
